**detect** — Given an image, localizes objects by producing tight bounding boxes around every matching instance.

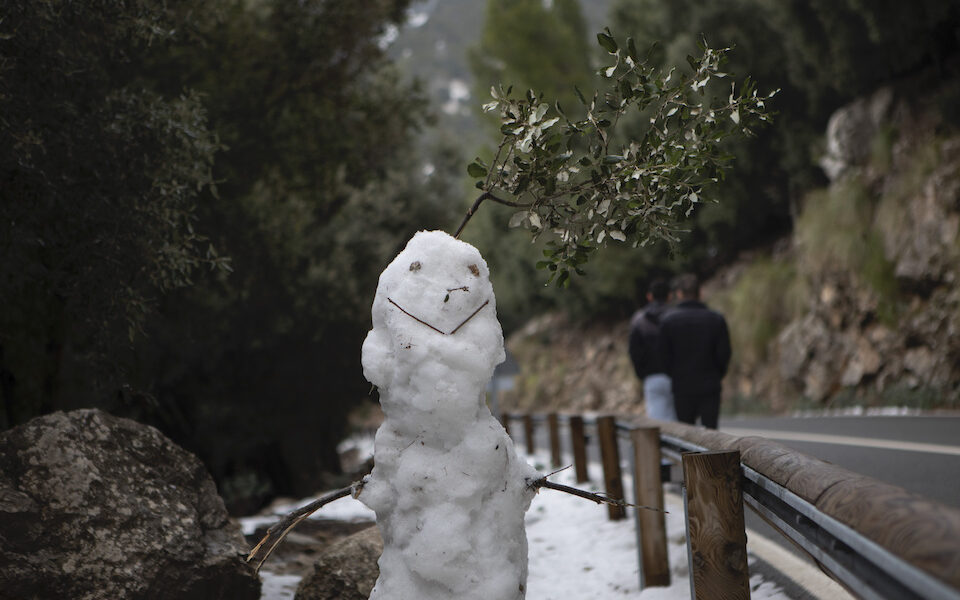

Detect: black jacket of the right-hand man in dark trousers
[660,300,730,397]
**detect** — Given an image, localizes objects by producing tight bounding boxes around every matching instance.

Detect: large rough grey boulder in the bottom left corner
[0,410,260,600]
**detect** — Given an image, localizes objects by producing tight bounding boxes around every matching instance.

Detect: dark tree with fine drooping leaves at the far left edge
[0,1,229,425]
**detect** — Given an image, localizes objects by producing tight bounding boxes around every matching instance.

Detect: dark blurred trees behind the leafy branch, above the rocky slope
[467,0,960,326]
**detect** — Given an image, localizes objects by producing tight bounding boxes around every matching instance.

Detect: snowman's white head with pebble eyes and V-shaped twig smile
[363,231,504,389]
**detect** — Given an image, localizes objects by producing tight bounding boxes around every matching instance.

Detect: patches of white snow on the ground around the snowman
[241,442,831,600]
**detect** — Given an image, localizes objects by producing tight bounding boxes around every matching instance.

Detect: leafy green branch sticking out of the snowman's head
[456,29,778,286]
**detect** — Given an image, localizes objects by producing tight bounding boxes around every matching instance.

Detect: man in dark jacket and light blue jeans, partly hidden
[630,279,677,421]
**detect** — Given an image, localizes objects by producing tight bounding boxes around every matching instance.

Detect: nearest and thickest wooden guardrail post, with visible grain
[683,450,750,600]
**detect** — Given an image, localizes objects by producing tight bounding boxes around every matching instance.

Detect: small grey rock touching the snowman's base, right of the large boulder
[295,527,383,600]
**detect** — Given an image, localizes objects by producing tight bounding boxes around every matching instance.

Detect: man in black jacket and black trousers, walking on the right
[660,274,730,429]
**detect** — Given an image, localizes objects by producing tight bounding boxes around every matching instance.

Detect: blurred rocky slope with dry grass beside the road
[504,82,960,413]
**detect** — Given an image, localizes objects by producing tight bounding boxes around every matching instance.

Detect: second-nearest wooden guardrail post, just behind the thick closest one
[630,427,670,590]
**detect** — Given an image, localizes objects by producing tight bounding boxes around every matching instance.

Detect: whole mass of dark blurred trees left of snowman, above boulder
[0,0,461,510]
